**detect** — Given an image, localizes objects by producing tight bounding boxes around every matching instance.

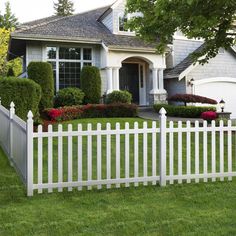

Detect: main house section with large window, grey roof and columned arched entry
[10,0,167,105]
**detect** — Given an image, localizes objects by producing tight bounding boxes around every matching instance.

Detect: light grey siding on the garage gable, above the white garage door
[186,51,236,93]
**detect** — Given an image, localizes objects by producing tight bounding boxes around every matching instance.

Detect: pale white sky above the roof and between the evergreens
[0,0,115,23]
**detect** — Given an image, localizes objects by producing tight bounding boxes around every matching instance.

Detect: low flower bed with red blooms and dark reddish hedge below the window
[44,103,138,121]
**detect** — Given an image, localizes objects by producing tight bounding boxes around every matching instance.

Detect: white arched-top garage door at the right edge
[194,78,236,118]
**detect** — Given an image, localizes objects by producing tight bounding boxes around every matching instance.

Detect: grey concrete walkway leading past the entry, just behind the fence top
[138,109,203,123]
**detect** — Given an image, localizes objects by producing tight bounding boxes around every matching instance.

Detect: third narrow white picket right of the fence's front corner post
[58,125,63,192]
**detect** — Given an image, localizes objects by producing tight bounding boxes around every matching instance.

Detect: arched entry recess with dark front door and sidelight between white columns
[119,57,149,105]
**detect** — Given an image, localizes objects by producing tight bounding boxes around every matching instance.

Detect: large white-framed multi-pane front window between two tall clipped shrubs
[47,47,92,91]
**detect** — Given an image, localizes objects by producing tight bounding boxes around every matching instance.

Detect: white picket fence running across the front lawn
[0,101,236,196]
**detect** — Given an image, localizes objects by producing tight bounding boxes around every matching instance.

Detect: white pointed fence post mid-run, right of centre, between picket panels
[159,108,166,186]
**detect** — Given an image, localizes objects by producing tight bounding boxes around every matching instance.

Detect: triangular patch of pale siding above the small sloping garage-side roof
[173,39,203,66]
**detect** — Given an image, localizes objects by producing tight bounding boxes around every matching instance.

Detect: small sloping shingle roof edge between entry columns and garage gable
[164,44,204,79]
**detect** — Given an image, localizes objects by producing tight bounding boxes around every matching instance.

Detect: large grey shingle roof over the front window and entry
[12,7,155,49]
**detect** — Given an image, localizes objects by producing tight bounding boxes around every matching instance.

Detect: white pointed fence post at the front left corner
[27,111,34,197]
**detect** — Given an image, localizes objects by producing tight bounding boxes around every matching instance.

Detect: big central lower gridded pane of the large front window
[59,62,81,89]
